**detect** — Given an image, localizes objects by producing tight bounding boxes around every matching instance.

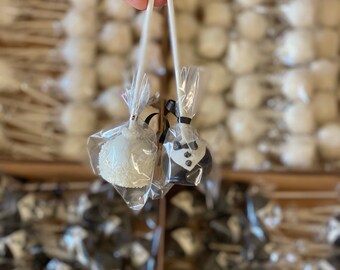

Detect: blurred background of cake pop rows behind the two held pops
[0,0,340,270]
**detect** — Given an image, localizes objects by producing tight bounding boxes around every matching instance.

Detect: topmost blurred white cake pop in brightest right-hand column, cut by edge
[280,0,317,27]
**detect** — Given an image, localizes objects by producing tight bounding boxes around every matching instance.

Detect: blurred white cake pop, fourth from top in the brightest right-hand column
[283,103,316,134]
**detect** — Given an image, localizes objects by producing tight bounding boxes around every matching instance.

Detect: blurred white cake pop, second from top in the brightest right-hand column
[276,29,316,66]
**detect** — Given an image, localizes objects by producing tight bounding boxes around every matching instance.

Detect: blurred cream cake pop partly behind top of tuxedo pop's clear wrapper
[205,62,232,94]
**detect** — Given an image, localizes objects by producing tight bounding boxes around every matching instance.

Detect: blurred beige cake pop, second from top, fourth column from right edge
[197,26,229,59]
